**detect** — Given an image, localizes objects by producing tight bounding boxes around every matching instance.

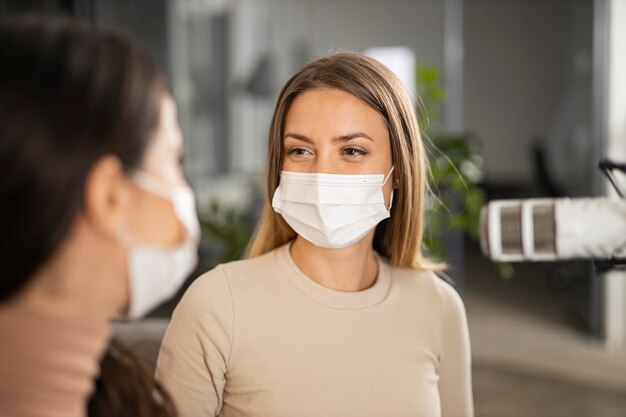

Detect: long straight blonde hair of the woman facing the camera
[246,52,439,269]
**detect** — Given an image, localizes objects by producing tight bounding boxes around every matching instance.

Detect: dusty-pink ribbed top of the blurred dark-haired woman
[0,306,110,417]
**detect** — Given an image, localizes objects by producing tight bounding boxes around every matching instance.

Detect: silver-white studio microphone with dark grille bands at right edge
[480,198,626,262]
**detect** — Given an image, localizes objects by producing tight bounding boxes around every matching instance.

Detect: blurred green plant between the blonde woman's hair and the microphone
[416,66,498,280]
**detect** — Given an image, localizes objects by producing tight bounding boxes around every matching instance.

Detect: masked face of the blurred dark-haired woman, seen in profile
[118,92,200,319]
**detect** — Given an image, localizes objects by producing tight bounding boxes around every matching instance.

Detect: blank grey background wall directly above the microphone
[464,0,592,194]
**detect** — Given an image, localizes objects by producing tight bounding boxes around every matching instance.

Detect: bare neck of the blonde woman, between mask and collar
[290,231,378,291]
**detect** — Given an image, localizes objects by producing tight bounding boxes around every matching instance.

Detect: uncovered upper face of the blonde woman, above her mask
[282,89,393,210]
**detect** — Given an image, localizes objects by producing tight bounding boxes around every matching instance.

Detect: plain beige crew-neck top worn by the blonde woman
[156,245,473,417]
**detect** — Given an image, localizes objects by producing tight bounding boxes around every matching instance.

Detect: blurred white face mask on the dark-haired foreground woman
[118,172,200,319]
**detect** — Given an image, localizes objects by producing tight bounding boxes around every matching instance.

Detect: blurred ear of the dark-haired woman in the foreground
[83,155,130,239]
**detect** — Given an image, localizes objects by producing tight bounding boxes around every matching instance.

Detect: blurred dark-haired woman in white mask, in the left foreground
[0,17,199,417]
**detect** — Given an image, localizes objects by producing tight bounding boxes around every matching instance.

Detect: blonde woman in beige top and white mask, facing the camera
[157,53,473,417]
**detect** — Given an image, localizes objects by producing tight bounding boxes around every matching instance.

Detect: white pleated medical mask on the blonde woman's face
[272,167,393,249]
